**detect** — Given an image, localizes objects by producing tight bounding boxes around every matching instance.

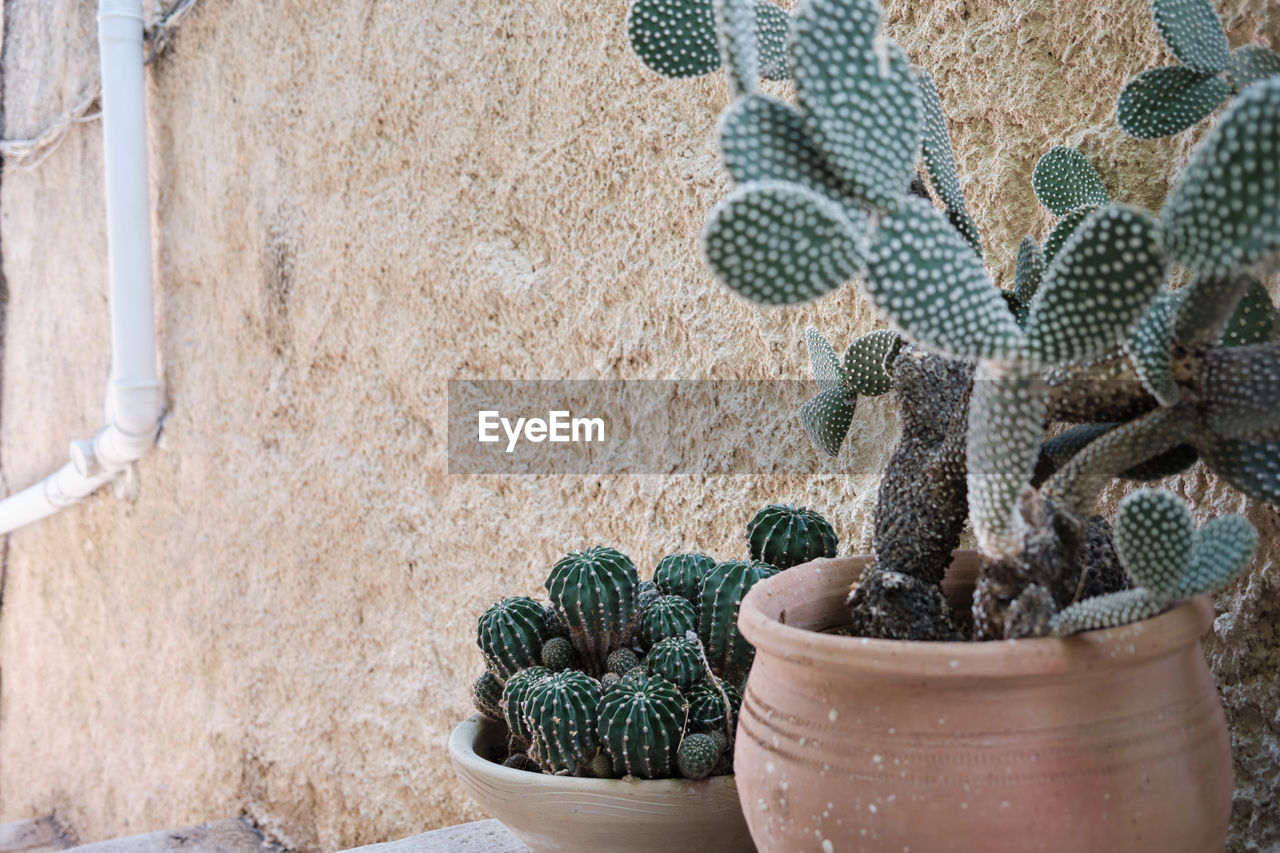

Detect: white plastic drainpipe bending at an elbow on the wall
[0,0,160,533]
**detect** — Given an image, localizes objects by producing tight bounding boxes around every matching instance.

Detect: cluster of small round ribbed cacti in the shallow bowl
[472,505,837,779]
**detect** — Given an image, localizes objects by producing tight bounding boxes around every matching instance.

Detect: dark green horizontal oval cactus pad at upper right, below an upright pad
[1116,65,1231,140]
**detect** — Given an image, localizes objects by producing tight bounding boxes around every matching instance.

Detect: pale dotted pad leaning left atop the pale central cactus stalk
[865,197,1023,359]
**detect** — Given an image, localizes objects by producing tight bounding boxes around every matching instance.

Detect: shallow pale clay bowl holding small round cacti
[449,713,755,853]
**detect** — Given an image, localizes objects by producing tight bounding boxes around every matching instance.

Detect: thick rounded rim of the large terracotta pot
[739,552,1213,680]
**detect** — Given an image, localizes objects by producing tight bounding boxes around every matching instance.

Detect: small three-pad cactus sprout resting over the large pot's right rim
[1052,489,1258,637]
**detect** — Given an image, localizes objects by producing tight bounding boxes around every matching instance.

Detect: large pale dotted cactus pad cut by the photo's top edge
[791,0,920,209]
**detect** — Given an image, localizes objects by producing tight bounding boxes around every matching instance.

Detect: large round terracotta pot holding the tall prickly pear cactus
[733,553,1233,853]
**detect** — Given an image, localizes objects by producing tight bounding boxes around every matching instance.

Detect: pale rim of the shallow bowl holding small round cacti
[449,713,737,797]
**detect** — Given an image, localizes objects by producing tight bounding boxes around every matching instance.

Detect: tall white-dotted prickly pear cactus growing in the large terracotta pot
[628,0,1280,639]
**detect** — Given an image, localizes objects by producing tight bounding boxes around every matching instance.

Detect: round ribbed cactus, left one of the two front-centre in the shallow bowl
[522,670,600,772]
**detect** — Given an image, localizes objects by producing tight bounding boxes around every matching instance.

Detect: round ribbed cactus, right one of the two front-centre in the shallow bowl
[598,675,687,779]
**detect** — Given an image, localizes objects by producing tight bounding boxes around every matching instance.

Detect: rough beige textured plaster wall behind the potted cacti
[0,0,1280,850]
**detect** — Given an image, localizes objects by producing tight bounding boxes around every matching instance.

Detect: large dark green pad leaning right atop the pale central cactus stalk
[1027,205,1165,365]
